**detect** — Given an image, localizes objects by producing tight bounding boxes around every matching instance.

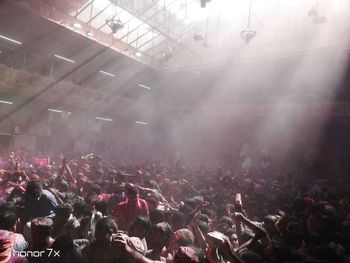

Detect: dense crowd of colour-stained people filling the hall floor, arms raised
[0,150,350,263]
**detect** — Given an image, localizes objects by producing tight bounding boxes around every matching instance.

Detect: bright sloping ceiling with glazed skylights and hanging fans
[2,0,350,71]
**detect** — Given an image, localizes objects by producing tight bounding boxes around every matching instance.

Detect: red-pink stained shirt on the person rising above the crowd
[114,198,148,230]
